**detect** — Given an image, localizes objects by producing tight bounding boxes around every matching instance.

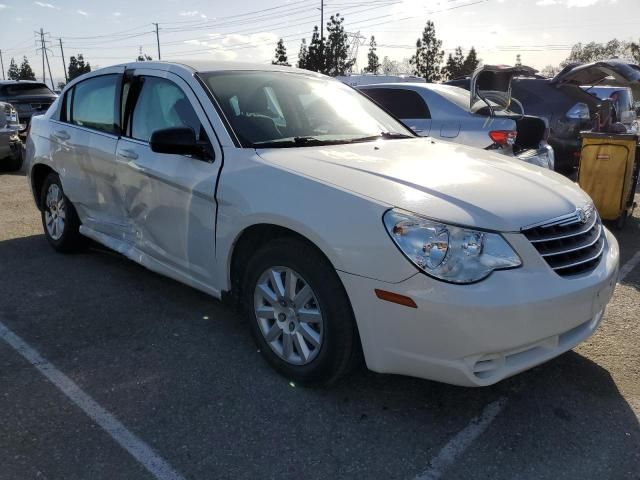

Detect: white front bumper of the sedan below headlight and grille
[340,226,619,386]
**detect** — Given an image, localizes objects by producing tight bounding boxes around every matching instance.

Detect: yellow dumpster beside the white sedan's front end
[578,132,640,228]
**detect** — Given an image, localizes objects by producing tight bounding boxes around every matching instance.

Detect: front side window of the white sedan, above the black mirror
[131,77,202,142]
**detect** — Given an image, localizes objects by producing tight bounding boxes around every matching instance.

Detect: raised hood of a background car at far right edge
[551,59,640,87]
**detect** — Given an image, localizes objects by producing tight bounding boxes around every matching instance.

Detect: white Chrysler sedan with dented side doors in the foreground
[27,62,618,386]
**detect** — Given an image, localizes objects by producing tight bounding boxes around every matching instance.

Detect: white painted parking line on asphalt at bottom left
[0,322,182,480]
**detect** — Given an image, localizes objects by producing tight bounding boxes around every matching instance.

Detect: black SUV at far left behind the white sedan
[0,80,58,128]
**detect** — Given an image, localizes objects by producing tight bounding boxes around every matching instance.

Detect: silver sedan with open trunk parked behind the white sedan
[357,65,554,170]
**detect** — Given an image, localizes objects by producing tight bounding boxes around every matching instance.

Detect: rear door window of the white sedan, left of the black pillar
[67,75,120,134]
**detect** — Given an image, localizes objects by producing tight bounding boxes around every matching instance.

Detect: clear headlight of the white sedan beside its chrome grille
[383,210,522,283]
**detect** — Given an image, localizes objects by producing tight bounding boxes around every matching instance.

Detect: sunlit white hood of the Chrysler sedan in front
[257,138,589,232]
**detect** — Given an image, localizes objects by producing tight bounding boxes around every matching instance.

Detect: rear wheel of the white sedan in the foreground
[40,172,85,253]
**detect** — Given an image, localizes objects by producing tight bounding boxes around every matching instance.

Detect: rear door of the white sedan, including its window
[50,72,127,237]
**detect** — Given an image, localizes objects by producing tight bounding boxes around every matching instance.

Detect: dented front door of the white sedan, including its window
[116,70,222,288]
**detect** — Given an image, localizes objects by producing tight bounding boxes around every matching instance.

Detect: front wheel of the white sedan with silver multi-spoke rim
[242,238,360,385]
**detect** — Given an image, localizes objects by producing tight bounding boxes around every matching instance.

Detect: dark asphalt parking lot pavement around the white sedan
[0,170,640,480]
